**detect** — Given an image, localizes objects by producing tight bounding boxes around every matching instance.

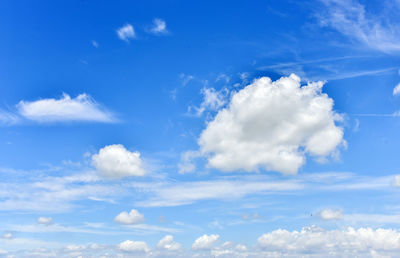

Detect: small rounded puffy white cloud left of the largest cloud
[92,144,146,179]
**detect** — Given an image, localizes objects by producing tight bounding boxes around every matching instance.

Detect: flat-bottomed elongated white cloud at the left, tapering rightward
[17,93,115,123]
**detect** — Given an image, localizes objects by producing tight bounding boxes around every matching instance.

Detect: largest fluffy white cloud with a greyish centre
[199,74,344,174]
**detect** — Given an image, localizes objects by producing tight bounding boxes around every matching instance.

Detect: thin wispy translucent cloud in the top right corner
[318,0,400,52]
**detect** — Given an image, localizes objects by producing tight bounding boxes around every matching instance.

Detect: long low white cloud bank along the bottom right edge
[258,227,400,257]
